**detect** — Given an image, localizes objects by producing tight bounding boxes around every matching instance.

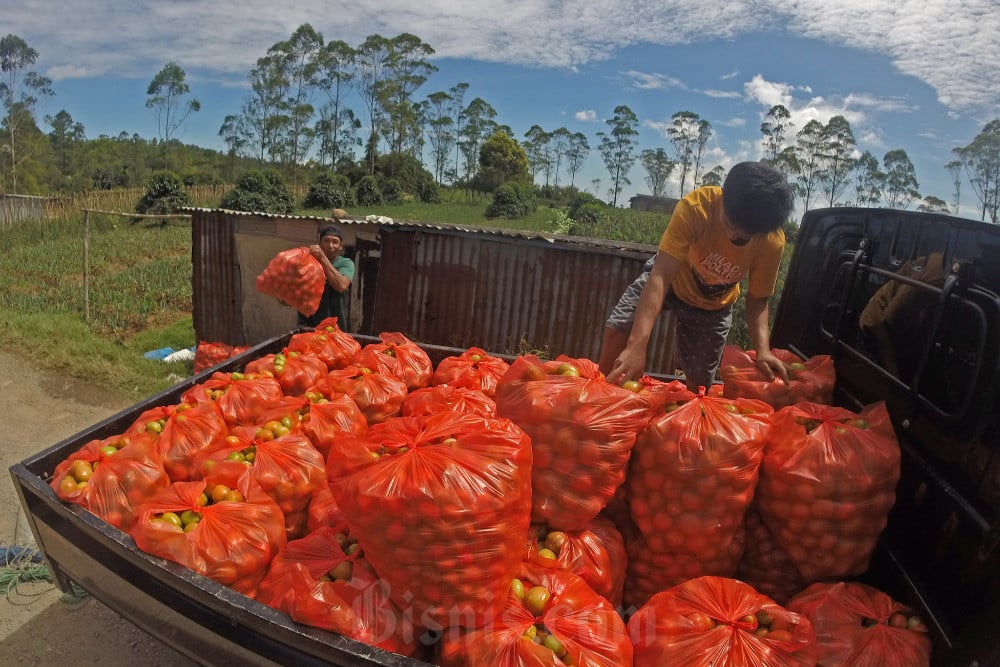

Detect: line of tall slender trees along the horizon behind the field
[0,24,1000,222]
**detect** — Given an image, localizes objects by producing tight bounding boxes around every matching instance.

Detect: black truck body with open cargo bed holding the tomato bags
[10,208,1000,667]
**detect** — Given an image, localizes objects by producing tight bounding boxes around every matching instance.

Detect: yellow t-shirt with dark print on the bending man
[659,186,785,310]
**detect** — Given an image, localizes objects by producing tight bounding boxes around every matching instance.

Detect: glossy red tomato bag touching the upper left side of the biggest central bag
[196,421,326,539]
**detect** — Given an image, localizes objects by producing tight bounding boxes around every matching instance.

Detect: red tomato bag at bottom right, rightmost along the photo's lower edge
[788,581,931,667]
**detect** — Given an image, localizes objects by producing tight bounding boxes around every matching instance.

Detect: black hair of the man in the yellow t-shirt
[722,162,793,234]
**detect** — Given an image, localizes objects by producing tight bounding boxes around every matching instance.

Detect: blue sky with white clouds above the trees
[7,0,1000,217]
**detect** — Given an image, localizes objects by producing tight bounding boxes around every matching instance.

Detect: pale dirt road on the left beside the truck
[0,352,196,667]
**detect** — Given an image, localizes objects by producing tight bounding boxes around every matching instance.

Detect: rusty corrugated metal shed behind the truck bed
[186,209,673,374]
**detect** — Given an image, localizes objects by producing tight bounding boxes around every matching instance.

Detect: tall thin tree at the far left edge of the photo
[0,35,53,192]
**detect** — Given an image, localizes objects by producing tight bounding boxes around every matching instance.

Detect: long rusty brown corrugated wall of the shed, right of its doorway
[373,229,673,374]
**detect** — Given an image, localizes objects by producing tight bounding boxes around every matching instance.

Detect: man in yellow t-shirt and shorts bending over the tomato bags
[600,162,792,391]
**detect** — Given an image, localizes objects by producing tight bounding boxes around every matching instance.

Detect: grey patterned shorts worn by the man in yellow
[605,258,733,387]
